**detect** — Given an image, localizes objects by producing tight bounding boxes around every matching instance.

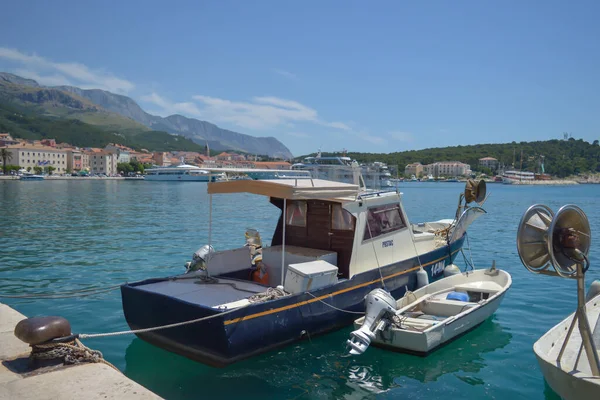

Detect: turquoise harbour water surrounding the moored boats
[0,180,600,400]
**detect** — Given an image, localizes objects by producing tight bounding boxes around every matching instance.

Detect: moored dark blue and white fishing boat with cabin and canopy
[121,179,485,366]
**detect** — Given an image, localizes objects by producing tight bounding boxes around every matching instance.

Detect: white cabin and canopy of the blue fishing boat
[203,179,448,287]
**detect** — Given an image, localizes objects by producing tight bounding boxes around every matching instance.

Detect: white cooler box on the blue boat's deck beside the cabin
[283,260,338,294]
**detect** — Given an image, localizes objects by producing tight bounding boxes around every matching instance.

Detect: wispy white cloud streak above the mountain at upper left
[0,47,135,93]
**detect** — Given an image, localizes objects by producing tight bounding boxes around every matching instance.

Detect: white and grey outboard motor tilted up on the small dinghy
[346,289,396,355]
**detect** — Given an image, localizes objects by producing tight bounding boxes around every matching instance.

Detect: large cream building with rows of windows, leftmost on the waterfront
[6,142,68,173]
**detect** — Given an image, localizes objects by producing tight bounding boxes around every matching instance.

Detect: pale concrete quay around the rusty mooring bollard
[0,303,161,400]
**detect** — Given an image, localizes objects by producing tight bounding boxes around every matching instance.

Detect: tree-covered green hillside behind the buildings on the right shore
[314,138,600,177]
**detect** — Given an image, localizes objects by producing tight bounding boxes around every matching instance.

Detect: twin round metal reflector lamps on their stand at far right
[517,204,600,376]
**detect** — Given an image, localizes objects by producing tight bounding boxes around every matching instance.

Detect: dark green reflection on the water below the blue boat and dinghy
[125,320,512,399]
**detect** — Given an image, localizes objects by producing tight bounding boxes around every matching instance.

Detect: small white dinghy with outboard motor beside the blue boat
[348,263,512,354]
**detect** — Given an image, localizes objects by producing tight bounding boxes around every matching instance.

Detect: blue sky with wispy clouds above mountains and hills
[0,0,600,155]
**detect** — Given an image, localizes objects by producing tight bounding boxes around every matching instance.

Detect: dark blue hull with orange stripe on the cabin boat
[121,237,464,367]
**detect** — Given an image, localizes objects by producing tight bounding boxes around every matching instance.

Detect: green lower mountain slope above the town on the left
[0,102,204,152]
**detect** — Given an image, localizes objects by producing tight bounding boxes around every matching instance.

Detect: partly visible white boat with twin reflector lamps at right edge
[517,205,600,400]
